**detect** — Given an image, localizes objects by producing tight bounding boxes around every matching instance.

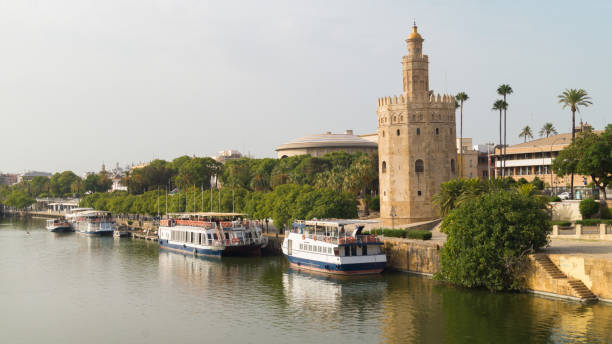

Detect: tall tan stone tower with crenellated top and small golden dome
[377,24,457,226]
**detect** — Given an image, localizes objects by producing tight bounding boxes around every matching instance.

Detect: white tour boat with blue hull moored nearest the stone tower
[281,220,387,275]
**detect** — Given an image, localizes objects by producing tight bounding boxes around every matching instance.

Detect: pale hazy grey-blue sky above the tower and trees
[0,0,612,173]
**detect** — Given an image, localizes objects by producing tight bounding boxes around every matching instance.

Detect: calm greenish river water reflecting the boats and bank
[0,219,612,344]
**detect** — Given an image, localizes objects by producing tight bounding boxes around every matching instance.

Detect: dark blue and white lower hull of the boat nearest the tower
[285,255,386,275]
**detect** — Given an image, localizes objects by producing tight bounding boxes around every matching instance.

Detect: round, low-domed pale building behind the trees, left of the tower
[276,130,378,159]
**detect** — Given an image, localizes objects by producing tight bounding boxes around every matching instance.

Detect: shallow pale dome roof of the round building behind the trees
[276,132,378,151]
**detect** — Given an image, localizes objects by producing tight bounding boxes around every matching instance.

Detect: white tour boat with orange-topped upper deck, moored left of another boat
[158,213,268,257]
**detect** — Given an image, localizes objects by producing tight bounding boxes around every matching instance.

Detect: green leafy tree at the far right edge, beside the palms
[552,124,612,203]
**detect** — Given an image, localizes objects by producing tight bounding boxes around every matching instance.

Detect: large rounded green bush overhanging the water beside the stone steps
[438,190,551,291]
